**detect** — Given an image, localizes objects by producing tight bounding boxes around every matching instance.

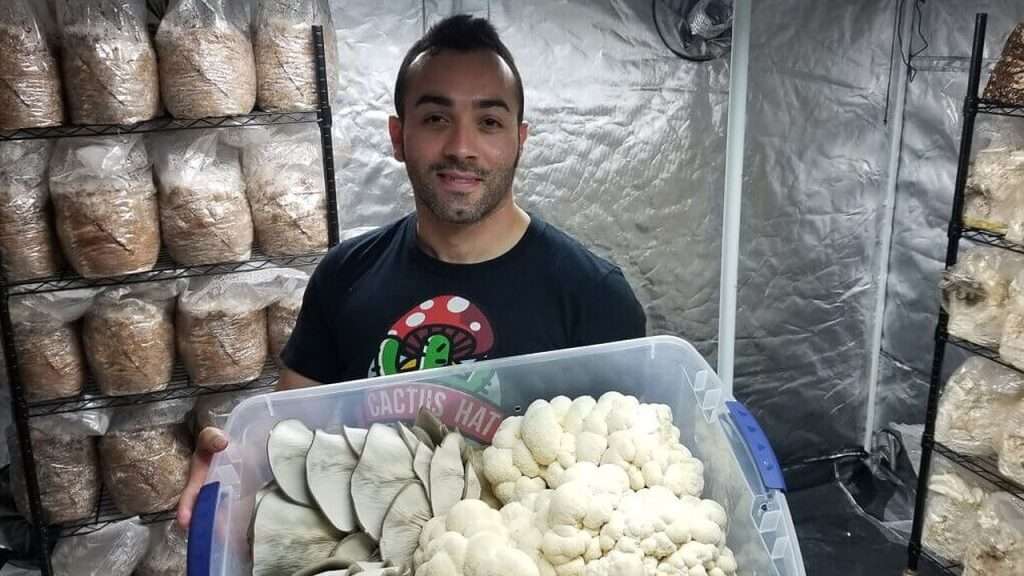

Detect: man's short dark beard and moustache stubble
[407,152,519,224]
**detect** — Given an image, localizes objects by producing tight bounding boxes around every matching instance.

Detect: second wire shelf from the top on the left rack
[0,250,326,296]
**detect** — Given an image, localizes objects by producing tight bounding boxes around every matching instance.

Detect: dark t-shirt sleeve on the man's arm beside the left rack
[281,265,344,383]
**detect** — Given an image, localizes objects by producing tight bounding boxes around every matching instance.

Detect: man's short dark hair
[394,14,523,122]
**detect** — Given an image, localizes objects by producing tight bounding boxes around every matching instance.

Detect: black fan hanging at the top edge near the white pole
[651,0,732,61]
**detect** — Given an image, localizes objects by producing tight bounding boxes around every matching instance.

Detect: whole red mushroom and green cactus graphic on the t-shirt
[371,295,495,376]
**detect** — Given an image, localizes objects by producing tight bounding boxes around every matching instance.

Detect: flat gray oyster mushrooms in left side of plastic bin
[250,410,483,576]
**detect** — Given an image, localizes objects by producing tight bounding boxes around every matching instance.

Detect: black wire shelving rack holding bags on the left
[0,26,339,576]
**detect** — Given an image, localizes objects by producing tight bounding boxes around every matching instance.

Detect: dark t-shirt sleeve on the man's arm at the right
[574,268,647,346]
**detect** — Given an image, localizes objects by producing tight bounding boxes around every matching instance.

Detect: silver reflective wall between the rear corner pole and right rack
[876,0,1024,440]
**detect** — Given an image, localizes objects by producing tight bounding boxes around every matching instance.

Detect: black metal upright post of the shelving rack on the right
[907,13,988,573]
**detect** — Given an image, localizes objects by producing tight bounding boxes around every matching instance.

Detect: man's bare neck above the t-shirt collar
[416,194,529,264]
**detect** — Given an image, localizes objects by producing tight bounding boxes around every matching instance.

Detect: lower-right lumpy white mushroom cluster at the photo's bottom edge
[450,462,736,576]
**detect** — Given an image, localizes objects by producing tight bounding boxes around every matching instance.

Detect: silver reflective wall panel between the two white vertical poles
[735,0,894,461]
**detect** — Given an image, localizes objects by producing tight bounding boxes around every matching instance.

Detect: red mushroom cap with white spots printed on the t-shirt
[388,295,495,362]
